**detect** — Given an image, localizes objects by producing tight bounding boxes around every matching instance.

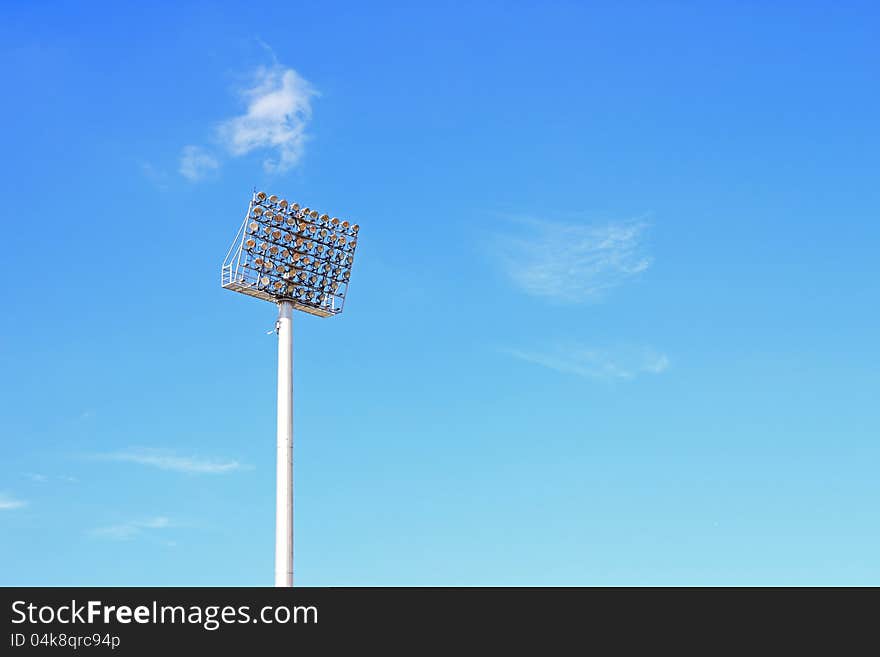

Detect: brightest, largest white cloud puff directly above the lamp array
[218,64,317,173]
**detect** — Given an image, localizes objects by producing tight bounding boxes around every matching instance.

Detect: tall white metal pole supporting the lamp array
[275,301,293,586]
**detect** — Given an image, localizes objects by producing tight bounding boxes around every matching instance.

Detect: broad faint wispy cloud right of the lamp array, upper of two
[496,219,651,303]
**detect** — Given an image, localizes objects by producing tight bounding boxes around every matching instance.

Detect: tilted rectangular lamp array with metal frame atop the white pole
[220,192,359,317]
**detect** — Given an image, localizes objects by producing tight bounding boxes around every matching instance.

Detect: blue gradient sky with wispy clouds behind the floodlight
[0,2,880,585]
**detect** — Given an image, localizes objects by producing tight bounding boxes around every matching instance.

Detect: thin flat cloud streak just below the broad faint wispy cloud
[504,342,669,381]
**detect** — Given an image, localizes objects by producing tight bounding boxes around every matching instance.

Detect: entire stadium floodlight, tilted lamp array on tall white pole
[220,191,359,586]
